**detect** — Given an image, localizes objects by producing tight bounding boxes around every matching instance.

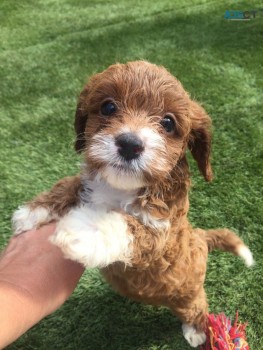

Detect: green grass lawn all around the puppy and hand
[0,0,263,350]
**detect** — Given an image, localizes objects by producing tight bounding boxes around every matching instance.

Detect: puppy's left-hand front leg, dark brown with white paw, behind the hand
[12,176,82,235]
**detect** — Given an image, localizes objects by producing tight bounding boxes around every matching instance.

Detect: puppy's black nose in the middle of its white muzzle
[115,132,144,160]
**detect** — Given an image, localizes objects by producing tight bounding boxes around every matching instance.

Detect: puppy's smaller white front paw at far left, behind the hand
[12,205,52,235]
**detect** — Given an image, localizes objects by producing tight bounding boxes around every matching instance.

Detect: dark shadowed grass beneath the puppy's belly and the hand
[7,278,186,350]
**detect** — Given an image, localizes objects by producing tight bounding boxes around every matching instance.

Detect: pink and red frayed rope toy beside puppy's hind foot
[200,312,249,350]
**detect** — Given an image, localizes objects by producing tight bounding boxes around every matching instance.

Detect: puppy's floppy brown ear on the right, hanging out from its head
[188,101,213,181]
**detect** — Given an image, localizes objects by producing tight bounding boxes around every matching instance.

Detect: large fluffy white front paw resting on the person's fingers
[51,206,132,267]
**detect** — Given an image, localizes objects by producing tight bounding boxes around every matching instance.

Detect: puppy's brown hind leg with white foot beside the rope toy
[168,288,208,347]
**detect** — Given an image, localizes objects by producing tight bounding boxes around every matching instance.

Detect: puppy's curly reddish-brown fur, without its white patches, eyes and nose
[21,61,251,336]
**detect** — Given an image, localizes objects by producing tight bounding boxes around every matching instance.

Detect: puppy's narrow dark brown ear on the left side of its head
[74,85,89,153]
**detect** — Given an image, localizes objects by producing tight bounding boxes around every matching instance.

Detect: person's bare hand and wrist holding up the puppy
[0,224,84,348]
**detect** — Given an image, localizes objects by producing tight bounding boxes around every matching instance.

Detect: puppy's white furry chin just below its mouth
[101,166,146,191]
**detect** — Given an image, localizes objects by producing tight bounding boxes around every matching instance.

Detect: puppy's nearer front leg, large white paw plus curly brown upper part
[52,209,164,269]
